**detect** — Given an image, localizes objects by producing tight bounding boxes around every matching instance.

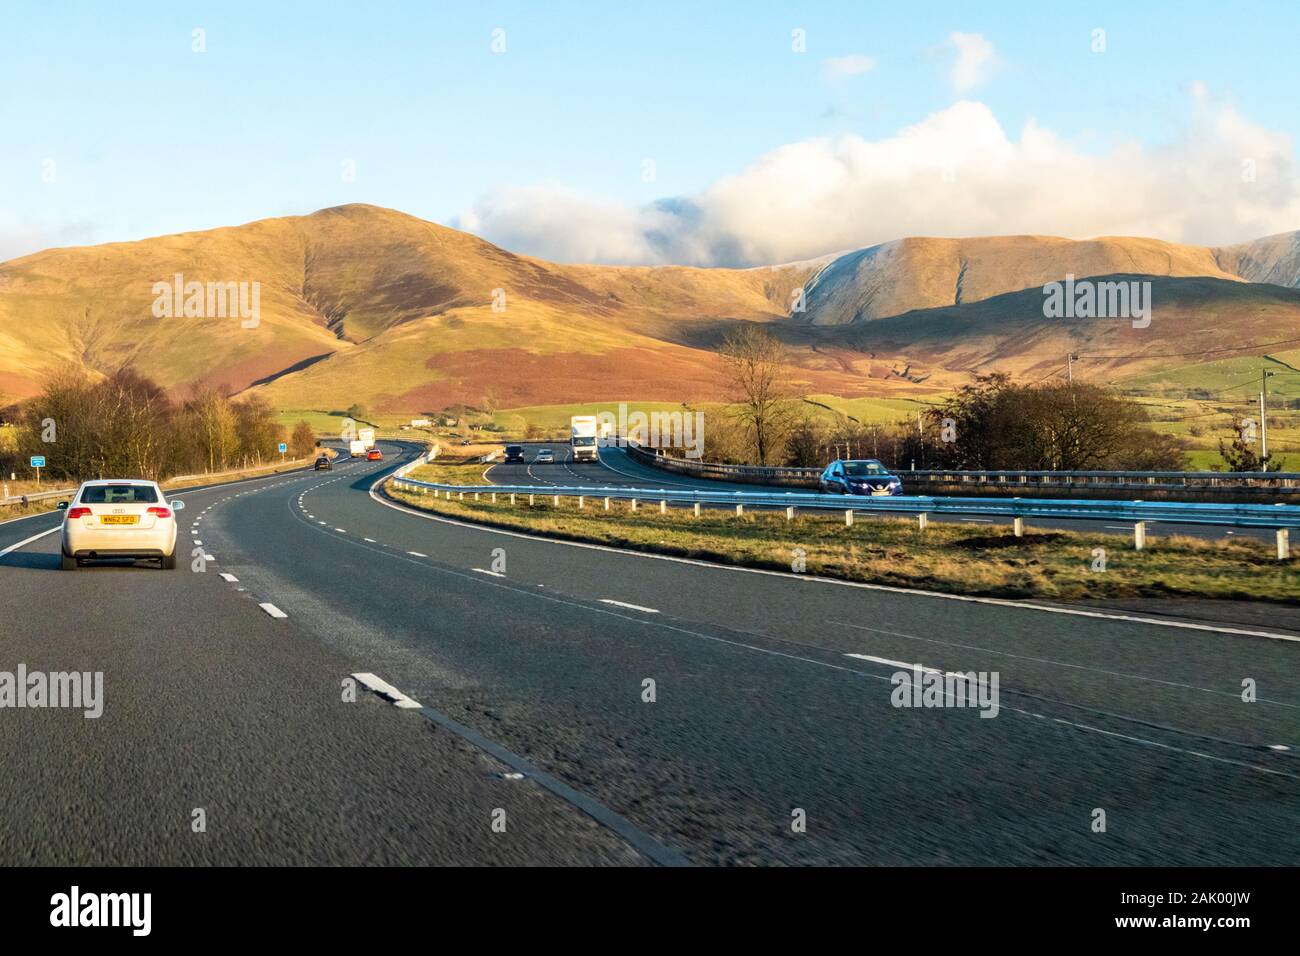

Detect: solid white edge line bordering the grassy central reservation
[369,476,1300,644]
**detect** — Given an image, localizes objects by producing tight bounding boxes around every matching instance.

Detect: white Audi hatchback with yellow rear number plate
[59,479,185,571]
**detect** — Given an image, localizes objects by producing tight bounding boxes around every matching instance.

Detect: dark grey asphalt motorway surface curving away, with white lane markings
[0,442,1300,865]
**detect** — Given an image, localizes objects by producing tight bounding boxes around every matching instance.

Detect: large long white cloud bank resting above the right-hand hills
[459,99,1300,265]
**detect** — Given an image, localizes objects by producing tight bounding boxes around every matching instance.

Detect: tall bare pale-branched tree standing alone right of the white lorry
[719,325,794,464]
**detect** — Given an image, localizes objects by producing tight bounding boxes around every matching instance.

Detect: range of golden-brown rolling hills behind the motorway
[0,204,1300,412]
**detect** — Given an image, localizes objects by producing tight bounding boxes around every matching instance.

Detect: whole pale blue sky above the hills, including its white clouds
[0,0,1300,264]
